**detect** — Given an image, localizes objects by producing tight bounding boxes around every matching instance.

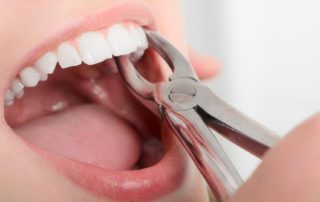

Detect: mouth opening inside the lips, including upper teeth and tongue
[5,23,162,170]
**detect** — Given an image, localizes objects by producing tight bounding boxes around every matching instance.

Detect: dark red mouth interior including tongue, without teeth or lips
[5,50,164,170]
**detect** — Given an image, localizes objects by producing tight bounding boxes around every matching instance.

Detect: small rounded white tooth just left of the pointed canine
[19,67,41,87]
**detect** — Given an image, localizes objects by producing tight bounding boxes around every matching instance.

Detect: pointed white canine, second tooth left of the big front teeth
[34,52,58,74]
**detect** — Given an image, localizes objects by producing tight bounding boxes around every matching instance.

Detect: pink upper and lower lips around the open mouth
[14,1,189,201]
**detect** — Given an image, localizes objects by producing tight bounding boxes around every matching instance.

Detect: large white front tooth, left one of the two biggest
[78,32,112,65]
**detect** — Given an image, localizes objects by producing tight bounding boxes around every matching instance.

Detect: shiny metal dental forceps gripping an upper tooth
[115,31,278,201]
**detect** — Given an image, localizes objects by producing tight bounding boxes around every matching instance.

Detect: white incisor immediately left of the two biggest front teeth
[57,43,81,69]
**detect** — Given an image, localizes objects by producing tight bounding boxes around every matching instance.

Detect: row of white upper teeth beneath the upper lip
[5,24,148,106]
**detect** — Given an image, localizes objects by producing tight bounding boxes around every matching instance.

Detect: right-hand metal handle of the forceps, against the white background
[196,86,280,158]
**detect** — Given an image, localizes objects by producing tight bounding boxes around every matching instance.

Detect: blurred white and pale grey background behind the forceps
[183,0,320,178]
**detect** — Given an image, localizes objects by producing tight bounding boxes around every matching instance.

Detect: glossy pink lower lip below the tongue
[31,128,189,201]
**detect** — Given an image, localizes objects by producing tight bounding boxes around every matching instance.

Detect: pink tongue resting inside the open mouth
[15,105,141,170]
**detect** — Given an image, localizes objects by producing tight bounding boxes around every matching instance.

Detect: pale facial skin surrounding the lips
[0,0,217,202]
